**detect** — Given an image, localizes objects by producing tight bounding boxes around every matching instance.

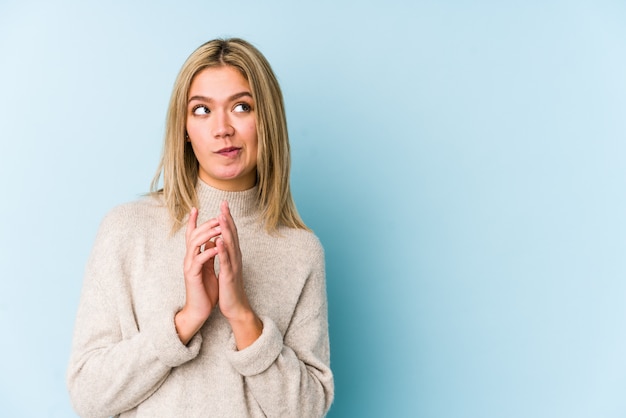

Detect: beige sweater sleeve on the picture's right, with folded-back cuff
[223,240,334,417]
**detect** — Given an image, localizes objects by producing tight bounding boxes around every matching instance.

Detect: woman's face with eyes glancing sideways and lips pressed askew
[187,66,258,191]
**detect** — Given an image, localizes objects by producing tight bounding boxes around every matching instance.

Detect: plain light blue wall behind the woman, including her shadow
[0,0,626,418]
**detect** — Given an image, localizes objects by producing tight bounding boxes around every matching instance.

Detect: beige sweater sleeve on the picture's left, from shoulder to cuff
[67,209,201,417]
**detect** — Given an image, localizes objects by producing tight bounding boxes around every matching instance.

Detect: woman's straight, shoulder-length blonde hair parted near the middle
[150,38,308,232]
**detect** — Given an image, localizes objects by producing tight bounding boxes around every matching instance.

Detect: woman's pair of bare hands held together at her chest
[174,201,263,350]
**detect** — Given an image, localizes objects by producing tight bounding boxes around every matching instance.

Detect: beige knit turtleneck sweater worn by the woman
[67,182,334,418]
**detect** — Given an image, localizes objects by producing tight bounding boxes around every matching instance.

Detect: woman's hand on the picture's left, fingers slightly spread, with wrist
[174,208,221,344]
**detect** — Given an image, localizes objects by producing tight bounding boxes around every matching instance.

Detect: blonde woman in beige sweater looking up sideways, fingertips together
[68,39,334,417]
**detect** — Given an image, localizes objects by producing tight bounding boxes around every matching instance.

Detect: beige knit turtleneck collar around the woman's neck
[196,179,260,219]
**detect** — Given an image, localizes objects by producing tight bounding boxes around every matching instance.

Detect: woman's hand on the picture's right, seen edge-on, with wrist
[215,201,263,350]
